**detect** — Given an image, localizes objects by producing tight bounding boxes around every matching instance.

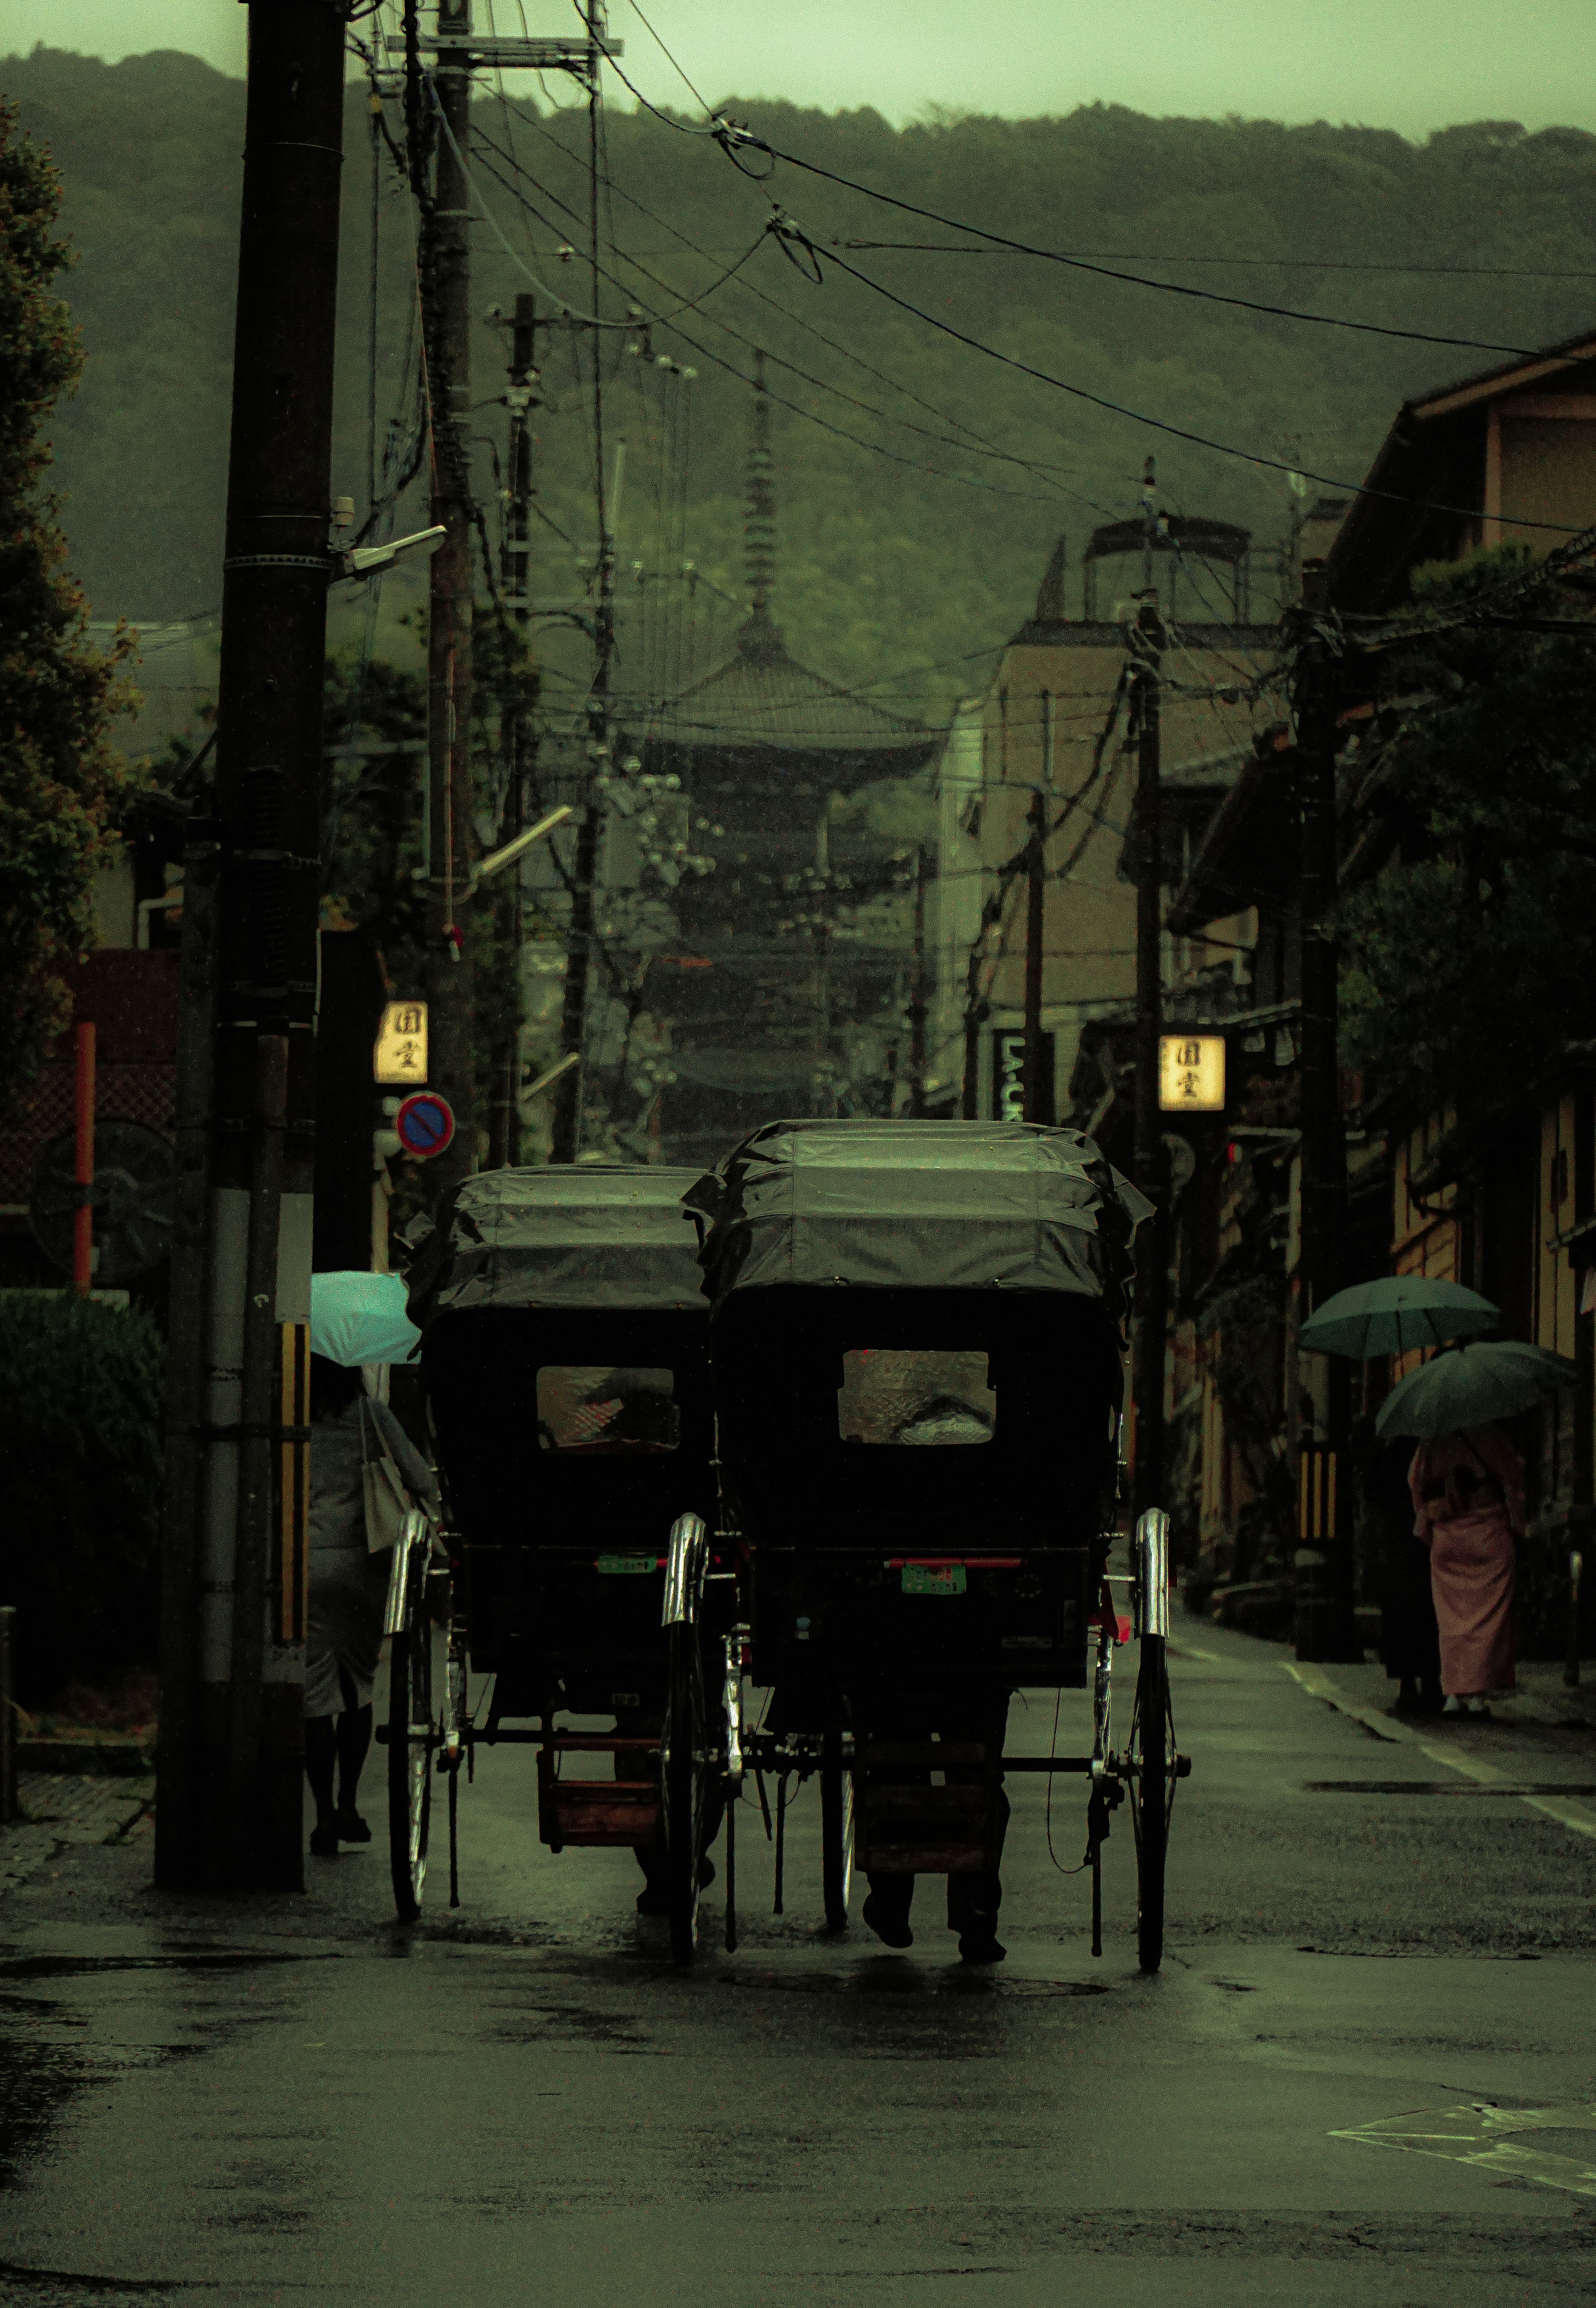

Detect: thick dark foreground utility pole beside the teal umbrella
[157,0,344,1890]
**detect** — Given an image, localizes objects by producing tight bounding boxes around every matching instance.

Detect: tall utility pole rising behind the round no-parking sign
[422,0,478,1196]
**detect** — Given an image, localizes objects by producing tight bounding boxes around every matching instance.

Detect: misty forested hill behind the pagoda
[0,49,1596,704]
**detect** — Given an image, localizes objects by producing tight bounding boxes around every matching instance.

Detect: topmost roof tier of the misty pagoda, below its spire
[658,605,936,766]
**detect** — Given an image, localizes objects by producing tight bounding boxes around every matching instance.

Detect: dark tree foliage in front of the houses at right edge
[1342,545,1596,1131]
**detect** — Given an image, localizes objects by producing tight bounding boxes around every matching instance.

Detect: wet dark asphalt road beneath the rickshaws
[0,1625,1596,2308]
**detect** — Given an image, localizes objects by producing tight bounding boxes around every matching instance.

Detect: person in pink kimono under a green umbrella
[1407,1426,1525,1715]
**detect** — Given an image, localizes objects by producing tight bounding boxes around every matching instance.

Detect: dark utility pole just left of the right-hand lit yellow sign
[1130,595,1169,1514]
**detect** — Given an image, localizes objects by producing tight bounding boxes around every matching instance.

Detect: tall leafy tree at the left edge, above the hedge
[0,97,140,1078]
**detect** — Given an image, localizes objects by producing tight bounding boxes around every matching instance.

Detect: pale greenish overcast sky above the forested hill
[12,0,1596,136]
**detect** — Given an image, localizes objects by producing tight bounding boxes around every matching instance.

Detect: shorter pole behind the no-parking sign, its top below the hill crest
[489,293,537,1170]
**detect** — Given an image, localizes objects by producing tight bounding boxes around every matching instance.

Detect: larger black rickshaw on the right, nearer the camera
[687,1119,1188,1973]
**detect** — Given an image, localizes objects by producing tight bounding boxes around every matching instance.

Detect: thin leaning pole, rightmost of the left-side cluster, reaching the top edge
[549,0,621,1161]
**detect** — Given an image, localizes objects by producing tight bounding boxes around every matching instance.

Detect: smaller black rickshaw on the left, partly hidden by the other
[378,1163,740,1960]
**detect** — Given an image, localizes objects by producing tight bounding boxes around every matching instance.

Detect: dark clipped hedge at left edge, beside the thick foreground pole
[0,1290,166,1706]
